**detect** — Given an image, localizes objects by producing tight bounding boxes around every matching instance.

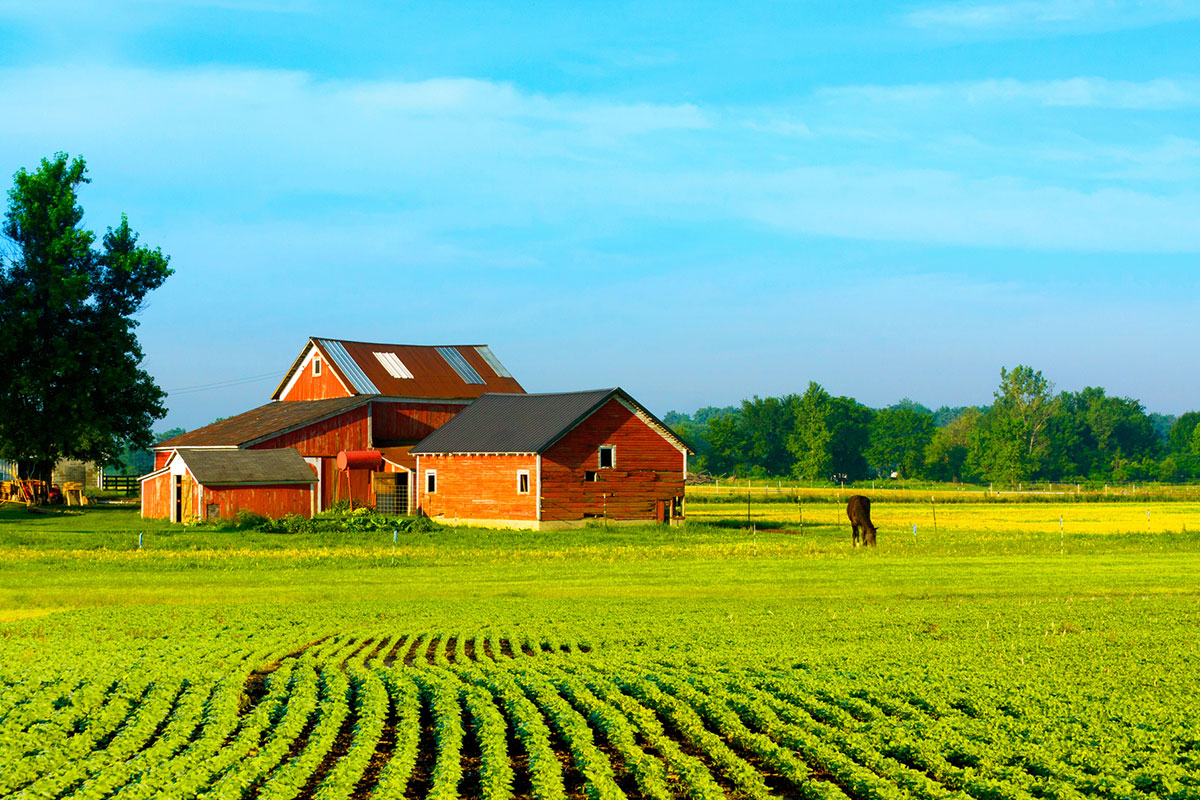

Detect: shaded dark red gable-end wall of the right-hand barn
[537,398,684,522]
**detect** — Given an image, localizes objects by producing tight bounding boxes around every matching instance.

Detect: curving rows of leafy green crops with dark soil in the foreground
[0,631,1200,800]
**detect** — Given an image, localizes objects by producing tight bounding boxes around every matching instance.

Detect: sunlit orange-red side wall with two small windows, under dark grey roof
[416,456,538,521]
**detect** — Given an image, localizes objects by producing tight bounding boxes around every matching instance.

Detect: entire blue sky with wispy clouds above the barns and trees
[0,0,1200,428]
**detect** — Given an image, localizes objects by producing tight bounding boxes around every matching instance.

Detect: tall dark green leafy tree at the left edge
[0,154,172,480]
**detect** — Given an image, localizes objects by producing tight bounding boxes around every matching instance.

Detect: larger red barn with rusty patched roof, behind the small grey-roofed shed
[142,338,524,519]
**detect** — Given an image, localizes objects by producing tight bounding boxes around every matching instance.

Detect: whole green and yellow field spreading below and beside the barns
[0,498,1200,800]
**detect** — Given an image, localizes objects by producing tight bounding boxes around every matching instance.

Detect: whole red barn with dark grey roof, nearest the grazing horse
[408,389,692,530]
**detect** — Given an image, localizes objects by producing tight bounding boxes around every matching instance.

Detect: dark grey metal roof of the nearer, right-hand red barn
[409,389,694,456]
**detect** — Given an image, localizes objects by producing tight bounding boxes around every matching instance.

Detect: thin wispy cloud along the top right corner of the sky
[905,0,1200,34]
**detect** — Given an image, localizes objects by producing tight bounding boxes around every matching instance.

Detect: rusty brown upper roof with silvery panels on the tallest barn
[271,337,524,399]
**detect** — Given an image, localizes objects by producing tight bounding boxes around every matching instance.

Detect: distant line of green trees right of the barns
[664,366,1200,485]
